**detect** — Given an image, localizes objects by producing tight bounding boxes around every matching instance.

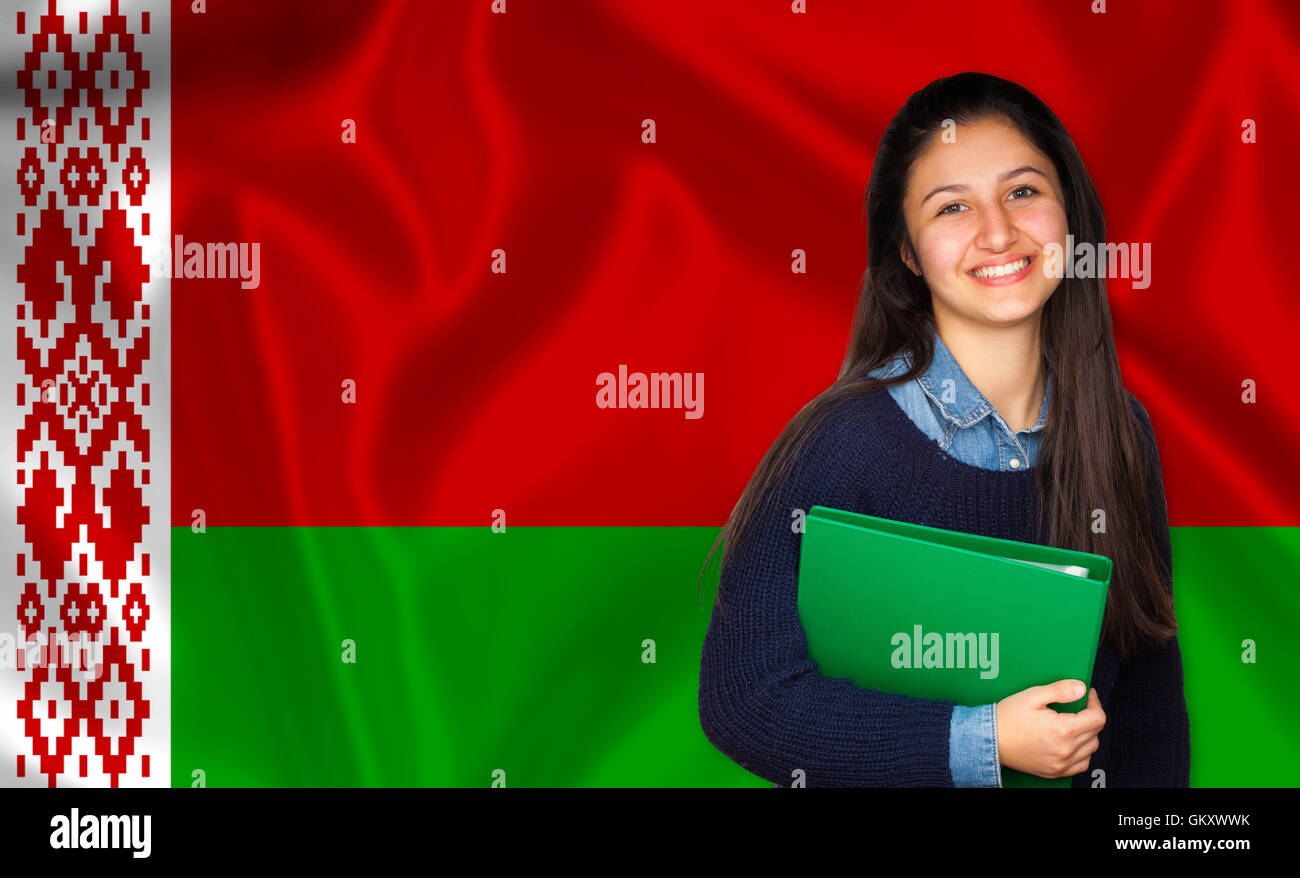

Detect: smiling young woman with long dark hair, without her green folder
[699,73,1188,787]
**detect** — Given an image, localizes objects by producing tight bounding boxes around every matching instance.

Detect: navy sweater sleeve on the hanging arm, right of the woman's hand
[1106,397,1191,787]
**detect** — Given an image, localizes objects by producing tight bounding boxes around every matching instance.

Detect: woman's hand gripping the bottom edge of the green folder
[995,680,1106,778]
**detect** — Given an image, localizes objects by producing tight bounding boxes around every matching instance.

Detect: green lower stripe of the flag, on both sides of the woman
[172,528,1300,787]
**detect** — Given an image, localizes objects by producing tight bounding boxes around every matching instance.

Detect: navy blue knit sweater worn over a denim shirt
[699,389,1190,787]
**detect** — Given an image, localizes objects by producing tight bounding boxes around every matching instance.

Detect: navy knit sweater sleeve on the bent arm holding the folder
[699,405,954,787]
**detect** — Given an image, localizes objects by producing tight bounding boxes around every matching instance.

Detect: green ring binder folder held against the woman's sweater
[798,506,1112,787]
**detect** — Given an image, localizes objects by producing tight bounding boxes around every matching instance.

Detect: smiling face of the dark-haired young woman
[902,120,1067,326]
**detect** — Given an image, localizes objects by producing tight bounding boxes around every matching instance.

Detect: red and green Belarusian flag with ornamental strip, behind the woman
[0,0,1300,786]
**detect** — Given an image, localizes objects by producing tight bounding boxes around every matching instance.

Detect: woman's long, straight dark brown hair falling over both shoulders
[701,73,1177,657]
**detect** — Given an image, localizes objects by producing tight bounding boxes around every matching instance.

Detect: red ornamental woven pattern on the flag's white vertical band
[13,0,151,787]
